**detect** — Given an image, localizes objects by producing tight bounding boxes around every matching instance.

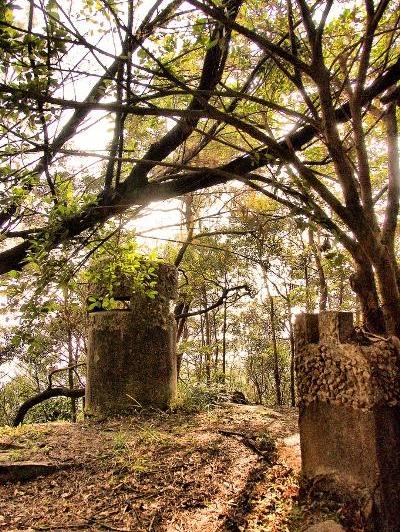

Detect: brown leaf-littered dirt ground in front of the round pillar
[0,403,354,532]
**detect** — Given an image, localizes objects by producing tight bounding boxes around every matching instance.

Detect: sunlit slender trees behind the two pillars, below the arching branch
[1,188,357,423]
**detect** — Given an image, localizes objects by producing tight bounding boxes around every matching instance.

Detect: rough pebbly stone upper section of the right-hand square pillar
[296,312,400,411]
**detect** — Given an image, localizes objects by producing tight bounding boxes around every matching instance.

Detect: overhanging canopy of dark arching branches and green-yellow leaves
[0,0,400,334]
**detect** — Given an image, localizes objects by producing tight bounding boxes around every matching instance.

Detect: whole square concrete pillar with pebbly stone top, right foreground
[296,312,400,532]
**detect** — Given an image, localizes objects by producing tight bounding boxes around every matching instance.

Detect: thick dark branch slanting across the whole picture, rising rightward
[0,58,400,274]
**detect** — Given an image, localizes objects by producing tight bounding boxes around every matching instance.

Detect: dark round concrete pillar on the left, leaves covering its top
[85,265,177,417]
